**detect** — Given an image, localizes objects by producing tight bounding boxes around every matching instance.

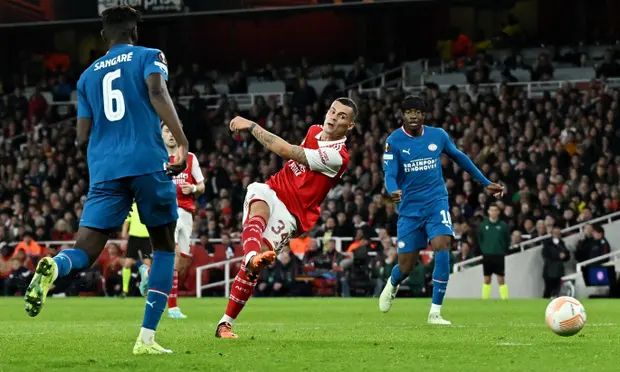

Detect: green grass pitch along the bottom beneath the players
[0,298,620,372]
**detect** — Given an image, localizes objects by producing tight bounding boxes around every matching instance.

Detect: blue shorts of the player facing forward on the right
[397,199,454,253]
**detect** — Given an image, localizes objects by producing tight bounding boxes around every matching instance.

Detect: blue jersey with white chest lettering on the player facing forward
[383,126,491,217]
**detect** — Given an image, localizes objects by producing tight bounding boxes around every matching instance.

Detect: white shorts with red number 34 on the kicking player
[243,182,297,253]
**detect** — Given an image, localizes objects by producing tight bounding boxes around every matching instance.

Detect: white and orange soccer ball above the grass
[545,296,586,336]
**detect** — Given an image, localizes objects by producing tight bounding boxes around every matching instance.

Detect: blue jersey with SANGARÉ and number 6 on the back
[77,44,168,184]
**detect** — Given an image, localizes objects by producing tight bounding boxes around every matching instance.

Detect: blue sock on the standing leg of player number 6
[142,251,174,330]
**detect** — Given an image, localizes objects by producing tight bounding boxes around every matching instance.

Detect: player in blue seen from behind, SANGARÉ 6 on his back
[25,6,188,354]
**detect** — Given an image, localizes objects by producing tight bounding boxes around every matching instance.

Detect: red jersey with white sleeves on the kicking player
[266,125,349,234]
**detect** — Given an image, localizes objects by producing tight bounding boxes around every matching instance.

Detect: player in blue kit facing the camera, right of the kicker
[379,96,504,325]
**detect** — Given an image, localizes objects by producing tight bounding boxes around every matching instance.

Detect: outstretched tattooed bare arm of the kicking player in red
[229,116,308,166]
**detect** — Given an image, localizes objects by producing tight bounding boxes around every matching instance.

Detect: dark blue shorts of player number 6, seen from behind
[80,171,178,230]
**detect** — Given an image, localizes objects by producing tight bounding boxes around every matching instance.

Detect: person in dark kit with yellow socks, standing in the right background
[478,204,510,300]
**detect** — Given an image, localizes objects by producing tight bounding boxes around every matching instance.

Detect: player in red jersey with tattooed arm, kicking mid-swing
[215,98,357,338]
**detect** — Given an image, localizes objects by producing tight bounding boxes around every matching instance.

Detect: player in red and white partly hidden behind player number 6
[161,124,205,319]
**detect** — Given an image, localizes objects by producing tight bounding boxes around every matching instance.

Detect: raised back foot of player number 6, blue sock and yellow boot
[24,248,89,317]
